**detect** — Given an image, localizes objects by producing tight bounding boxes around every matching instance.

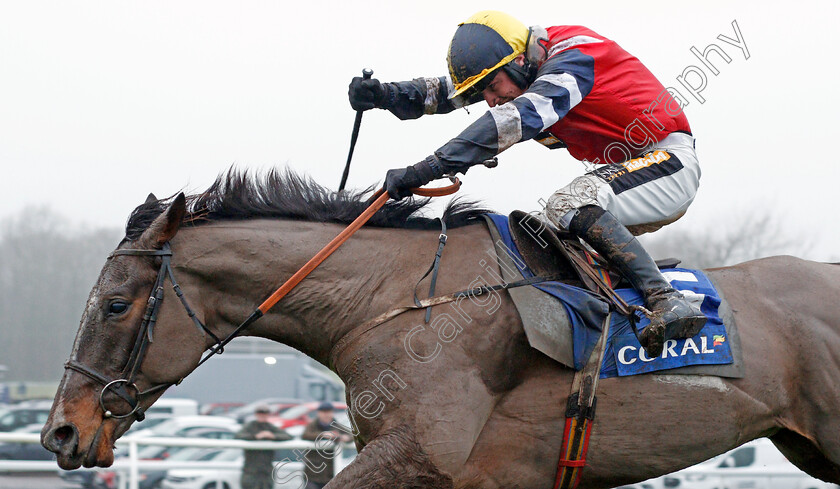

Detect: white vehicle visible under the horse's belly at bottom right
[654,438,838,489]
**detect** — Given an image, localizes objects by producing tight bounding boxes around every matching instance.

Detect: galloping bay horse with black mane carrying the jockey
[41,171,840,489]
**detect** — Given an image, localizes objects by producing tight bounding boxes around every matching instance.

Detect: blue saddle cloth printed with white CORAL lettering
[488,214,733,378]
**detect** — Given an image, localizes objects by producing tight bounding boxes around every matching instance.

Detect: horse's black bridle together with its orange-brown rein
[64,178,461,421]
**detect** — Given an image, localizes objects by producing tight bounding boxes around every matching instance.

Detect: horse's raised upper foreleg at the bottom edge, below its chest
[325,426,453,489]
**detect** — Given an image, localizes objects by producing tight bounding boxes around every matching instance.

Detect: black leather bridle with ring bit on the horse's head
[64,242,231,421]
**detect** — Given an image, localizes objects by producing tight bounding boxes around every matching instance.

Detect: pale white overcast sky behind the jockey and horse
[0,0,840,260]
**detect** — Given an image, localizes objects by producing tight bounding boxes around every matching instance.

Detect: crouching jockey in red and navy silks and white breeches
[349,11,705,355]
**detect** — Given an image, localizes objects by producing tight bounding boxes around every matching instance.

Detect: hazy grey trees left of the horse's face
[0,207,120,381]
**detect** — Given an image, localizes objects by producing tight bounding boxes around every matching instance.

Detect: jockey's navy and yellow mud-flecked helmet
[446,10,535,97]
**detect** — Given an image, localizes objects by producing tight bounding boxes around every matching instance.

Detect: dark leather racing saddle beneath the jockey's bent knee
[508,211,680,293]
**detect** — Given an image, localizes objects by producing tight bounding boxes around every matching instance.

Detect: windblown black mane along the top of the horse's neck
[125,168,491,240]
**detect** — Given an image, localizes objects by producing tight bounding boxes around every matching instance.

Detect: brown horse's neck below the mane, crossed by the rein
[173,220,437,364]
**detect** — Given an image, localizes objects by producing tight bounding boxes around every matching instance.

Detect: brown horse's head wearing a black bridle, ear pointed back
[41,194,206,470]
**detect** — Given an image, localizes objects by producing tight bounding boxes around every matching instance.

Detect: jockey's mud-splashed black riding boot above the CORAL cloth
[569,205,706,357]
